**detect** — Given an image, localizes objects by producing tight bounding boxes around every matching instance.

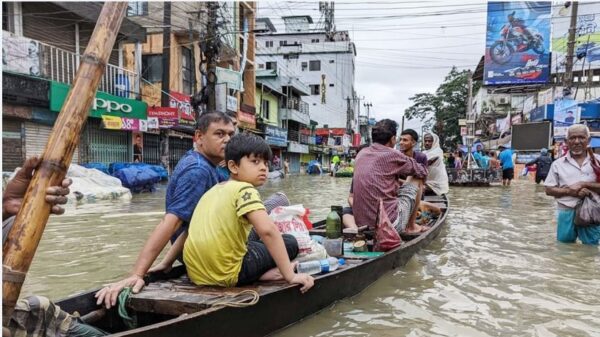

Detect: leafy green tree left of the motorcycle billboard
[404,67,476,151]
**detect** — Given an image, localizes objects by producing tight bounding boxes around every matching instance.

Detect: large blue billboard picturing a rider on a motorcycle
[484,1,551,85]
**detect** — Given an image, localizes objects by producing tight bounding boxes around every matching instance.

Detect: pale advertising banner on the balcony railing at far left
[2,33,42,76]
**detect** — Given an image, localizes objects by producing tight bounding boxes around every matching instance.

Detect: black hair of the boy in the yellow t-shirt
[225,133,273,165]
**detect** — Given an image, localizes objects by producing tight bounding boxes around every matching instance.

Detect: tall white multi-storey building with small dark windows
[256,16,358,130]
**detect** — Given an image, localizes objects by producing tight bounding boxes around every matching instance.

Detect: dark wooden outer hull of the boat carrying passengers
[58,194,448,337]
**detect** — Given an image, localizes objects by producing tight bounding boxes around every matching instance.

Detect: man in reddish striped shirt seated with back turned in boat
[353,119,428,233]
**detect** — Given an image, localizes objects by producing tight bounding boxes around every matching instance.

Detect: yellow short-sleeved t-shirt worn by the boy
[183,180,265,287]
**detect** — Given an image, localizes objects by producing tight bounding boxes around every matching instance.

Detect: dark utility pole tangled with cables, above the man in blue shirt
[204,1,219,112]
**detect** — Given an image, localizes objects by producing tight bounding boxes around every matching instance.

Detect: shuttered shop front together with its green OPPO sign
[50,82,148,164]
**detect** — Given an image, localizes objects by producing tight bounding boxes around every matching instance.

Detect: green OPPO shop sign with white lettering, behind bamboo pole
[50,82,148,119]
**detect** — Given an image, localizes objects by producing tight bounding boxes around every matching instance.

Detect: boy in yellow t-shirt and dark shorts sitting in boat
[183,134,314,292]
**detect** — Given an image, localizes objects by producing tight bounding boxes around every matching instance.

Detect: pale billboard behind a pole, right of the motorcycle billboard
[552,1,600,73]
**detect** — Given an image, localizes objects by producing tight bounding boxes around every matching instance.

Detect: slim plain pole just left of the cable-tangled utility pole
[160,1,171,173]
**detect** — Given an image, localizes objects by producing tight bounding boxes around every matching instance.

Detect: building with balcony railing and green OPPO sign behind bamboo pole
[2,2,147,171]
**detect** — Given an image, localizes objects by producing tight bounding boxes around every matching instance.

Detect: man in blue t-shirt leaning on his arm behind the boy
[96,113,235,308]
